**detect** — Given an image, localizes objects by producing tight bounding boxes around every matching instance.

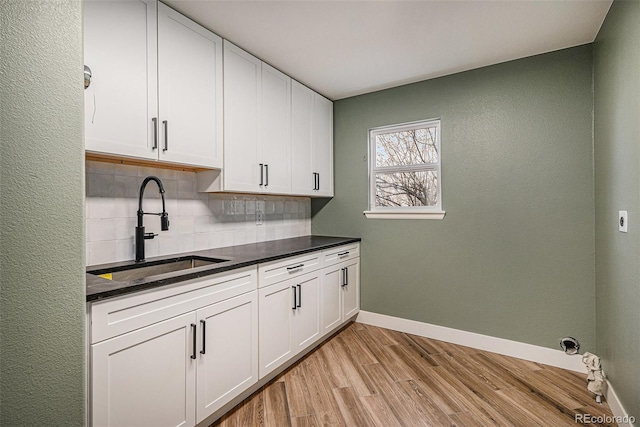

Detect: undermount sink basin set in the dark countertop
[88,255,229,282]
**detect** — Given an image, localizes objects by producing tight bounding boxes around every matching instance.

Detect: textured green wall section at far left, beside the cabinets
[0,0,85,427]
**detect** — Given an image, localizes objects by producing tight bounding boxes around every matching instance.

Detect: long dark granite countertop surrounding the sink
[87,236,360,301]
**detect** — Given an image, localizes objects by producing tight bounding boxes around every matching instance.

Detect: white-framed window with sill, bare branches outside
[365,120,444,219]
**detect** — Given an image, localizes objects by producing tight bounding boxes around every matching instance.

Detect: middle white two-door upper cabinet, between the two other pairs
[222,40,291,194]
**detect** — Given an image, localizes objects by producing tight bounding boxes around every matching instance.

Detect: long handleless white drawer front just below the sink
[90,267,258,343]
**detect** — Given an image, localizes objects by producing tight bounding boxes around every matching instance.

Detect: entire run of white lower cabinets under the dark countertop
[89,243,360,427]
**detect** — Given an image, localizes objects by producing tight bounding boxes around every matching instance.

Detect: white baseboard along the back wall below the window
[356,311,587,374]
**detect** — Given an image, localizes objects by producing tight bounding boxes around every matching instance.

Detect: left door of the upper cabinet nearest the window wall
[291,80,315,195]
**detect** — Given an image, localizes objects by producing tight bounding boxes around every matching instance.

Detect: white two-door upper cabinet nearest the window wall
[291,81,333,197]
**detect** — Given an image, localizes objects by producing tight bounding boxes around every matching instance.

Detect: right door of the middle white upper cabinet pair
[258,63,291,194]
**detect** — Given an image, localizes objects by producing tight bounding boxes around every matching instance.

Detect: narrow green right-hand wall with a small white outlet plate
[593,1,640,419]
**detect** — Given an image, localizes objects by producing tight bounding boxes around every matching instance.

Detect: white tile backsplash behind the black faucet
[86,161,311,265]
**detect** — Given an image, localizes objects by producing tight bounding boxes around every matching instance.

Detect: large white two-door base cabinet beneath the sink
[90,267,258,427]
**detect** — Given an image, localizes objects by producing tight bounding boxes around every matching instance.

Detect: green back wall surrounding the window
[312,45,595,351]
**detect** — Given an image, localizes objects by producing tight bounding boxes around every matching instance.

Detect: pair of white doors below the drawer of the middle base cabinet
[258,271,321,378]
